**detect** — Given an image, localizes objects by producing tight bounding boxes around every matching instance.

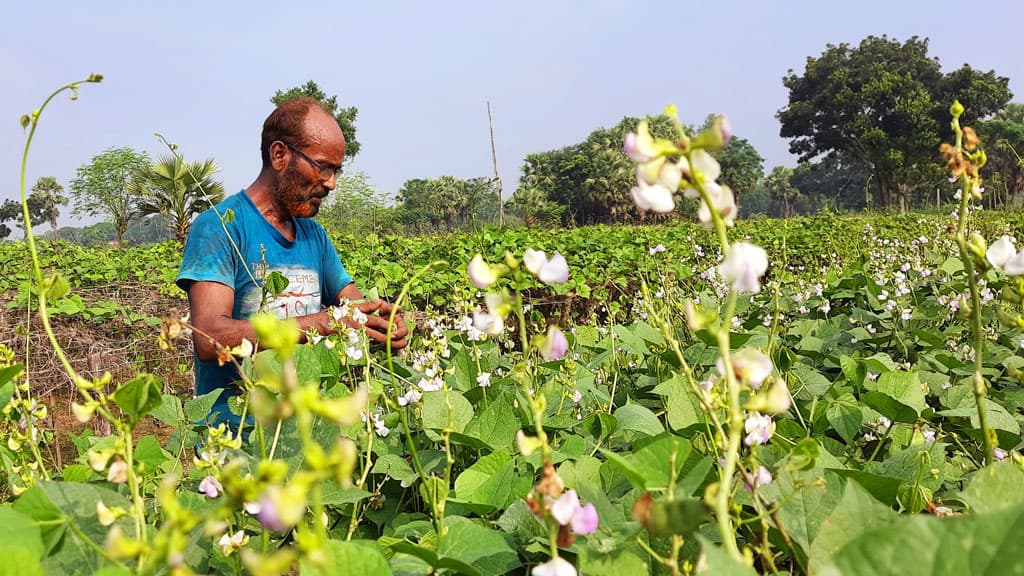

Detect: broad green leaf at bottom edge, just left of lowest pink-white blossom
[437,517,521,574]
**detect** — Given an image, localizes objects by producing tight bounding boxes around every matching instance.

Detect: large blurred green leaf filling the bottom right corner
[818,506,1024,576]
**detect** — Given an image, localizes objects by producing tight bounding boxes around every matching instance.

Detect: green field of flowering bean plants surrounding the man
[6,203,1024,574]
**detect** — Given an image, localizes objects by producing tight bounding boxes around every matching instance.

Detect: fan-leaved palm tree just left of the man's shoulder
[130,156,224,243]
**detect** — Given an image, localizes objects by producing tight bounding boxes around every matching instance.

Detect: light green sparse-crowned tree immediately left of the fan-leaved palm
[71,147,150,246]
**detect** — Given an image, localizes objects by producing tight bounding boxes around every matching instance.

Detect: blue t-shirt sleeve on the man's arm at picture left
[176,210,238,292]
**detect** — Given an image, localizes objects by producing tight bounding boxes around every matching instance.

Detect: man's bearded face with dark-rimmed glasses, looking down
[276,110,345,218]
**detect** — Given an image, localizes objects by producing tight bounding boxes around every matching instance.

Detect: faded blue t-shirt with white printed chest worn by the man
[177,191,352,426]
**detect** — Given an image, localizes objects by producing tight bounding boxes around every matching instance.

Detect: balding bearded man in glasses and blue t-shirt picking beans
[177,97,409,426]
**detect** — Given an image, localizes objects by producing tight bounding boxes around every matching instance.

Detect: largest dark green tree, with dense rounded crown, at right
[778,36,1012,207]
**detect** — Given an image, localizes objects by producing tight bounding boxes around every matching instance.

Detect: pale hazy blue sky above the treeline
[0,0,1024,225]
